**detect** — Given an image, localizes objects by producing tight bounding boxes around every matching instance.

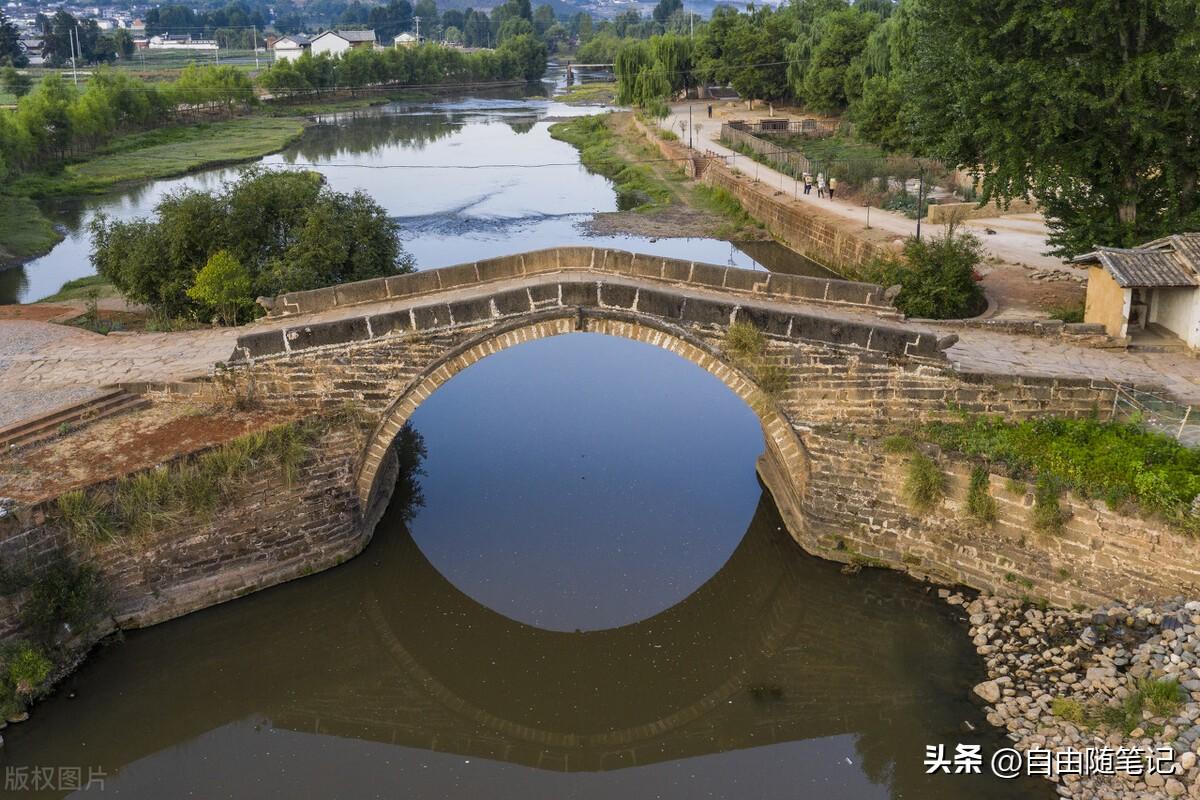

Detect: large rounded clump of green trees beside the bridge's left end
[91,169,413,323]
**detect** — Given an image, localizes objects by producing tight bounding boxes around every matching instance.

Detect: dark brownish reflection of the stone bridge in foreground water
[0,494,1050,799]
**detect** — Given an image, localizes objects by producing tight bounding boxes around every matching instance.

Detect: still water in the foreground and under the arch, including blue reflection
[0,333,1052,800]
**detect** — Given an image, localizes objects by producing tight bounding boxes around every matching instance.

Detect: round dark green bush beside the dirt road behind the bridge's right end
[863,227,988,319]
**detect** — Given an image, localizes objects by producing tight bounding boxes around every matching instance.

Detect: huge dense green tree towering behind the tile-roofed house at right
[905,0,1200,255]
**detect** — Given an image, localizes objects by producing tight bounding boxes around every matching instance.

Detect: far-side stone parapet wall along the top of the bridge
[262,247,898,318]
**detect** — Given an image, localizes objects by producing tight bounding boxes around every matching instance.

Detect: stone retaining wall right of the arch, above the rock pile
[760,429,1200,607]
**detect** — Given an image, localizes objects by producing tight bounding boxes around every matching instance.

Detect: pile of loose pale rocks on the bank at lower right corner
[940,590,1200,800]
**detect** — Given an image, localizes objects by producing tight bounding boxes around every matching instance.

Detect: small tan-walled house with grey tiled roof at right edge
[1073,233,1200,348]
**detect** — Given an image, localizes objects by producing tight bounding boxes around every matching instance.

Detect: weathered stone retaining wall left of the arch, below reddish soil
[0,429,390,639]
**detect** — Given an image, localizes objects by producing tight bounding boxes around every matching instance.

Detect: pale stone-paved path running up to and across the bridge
[0,272,1200,425]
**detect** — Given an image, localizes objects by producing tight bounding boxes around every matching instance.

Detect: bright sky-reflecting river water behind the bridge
[0,76,829,305]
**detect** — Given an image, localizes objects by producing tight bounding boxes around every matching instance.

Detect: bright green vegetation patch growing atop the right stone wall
[919,416,1200,531]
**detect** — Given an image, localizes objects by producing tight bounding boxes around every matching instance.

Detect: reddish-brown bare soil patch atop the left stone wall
[0,403,297,503]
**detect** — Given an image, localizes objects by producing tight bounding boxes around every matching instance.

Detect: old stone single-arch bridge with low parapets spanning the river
[204,247,1111,604]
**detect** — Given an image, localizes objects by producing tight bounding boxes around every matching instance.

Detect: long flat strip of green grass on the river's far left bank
[14,116,305,196]
